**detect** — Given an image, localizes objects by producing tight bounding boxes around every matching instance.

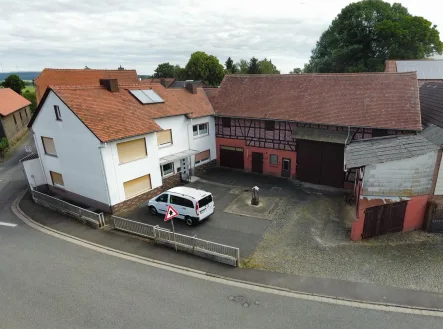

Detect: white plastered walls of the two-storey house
[28,91,216,206]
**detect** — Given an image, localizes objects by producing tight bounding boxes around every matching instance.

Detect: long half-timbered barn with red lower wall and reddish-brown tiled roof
[211,73,421,189]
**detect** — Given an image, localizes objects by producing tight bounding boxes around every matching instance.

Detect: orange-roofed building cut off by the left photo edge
[0,88,31,143]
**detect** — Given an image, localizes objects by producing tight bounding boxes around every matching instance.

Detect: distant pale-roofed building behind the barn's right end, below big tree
[385,59,443,86]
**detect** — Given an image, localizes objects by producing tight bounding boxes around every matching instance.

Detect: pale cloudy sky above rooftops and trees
[0,0,443,74]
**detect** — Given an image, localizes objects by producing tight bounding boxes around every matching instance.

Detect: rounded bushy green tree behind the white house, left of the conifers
[186,51,225,86]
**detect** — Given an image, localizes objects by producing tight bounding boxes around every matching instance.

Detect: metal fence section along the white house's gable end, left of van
[31,190,105,227]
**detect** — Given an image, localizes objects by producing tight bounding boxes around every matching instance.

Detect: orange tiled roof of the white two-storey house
[30,83,214,142]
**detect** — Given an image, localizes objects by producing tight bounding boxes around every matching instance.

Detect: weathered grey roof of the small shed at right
[345,135,438,169]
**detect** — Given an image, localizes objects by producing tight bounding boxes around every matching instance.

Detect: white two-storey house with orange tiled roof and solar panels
[27,79,216,212]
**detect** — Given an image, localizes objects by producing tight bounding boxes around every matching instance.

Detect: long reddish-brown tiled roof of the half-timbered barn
[211,72,421,130]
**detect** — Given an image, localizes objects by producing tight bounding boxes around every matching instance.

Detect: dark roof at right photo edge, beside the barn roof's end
[420,82,443,128]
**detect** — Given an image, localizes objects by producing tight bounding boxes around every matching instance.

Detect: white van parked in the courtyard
[148,186,214,226]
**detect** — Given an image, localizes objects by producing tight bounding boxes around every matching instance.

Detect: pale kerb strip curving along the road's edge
[11,190,443,318]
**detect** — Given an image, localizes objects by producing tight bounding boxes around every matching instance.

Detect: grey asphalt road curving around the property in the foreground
[0,135,442,329]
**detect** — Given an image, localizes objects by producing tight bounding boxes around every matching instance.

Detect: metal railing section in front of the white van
[111,216,240,266]
